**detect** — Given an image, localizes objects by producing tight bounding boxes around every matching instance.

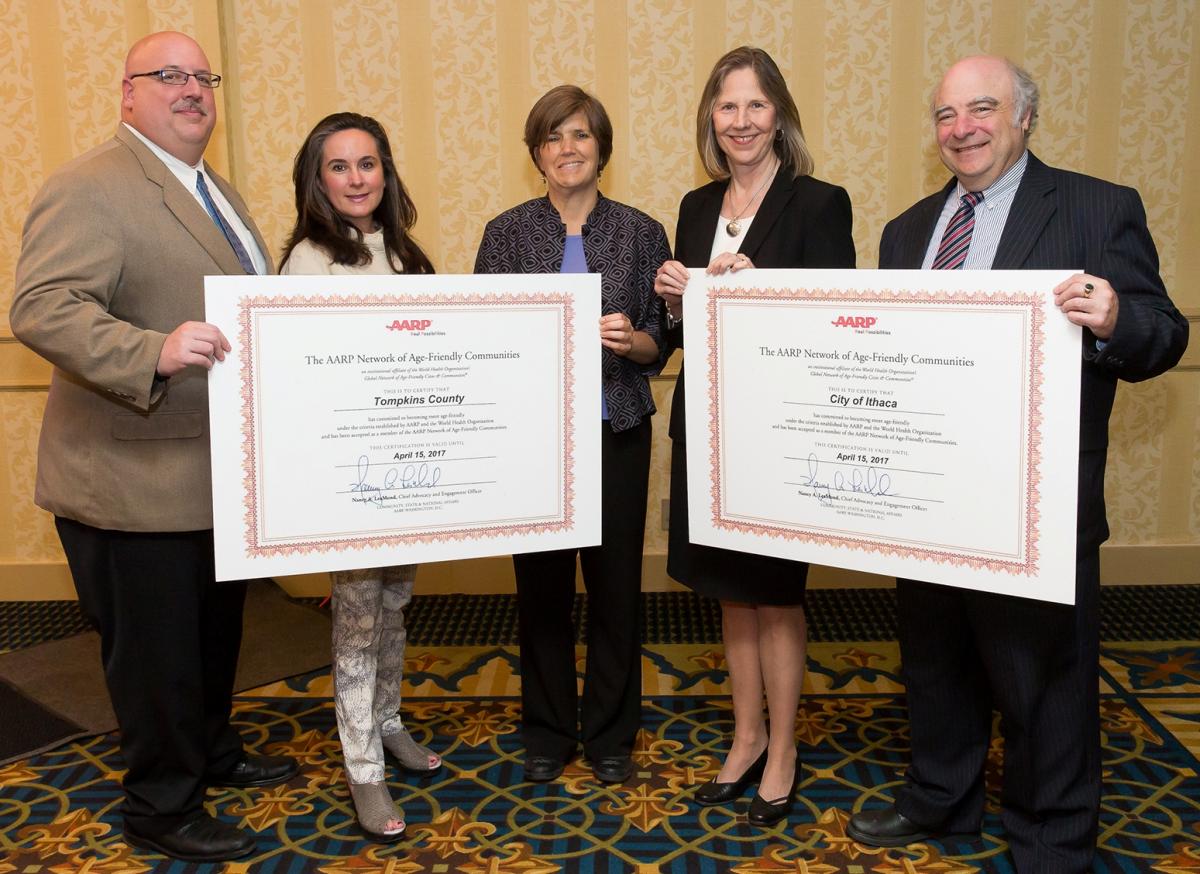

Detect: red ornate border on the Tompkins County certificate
[238,293,575,558]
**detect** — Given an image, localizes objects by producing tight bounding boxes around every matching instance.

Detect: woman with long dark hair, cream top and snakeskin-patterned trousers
[280,113,442,843]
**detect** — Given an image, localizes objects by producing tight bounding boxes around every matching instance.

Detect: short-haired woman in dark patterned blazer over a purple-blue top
[475,85,671,783]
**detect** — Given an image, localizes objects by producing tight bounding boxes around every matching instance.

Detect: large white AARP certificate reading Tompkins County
[205,275,600,580]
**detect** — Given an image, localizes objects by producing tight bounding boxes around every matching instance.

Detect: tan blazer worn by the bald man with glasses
[10,125,270,532]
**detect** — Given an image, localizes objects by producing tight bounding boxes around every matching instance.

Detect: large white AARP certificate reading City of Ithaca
[684,270,1081,604]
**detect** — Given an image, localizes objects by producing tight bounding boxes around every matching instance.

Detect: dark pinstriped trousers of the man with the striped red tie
[896,547,1100,874]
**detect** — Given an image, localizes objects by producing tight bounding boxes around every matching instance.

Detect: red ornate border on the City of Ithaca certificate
[706,287,1045,576]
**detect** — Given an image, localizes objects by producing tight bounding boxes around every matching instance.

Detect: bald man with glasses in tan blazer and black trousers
[11,32,296,861]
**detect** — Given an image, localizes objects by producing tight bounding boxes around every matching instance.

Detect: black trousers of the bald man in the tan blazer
[55,517,246,833]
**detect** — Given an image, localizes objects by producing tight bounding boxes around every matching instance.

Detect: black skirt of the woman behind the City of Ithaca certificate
[667,439,809,606]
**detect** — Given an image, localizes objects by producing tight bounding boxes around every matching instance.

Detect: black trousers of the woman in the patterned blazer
[512,417,650,761]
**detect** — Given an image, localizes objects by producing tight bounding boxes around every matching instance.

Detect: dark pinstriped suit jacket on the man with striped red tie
[878,152,1188,550]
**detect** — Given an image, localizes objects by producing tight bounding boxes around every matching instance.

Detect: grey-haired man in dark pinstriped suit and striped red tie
[846,58,1188,874]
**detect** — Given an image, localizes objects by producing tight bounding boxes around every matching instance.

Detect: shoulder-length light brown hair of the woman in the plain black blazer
[696,46,814,180]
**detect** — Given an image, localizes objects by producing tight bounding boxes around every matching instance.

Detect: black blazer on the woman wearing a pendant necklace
[667,167,854,443]
